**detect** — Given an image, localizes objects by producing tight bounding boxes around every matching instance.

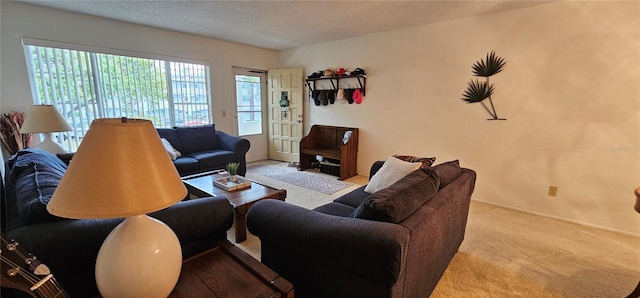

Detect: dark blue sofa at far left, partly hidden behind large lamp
[0,148,233,297]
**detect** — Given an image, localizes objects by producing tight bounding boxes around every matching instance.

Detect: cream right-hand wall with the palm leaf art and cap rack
[278,1,640,235]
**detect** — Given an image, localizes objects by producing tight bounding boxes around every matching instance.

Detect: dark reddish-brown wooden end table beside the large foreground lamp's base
[169,240,294,298]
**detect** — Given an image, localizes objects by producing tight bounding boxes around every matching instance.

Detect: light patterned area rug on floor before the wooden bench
[247,164,353,195]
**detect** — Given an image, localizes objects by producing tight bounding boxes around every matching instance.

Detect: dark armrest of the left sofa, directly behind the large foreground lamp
[6,197,233,296]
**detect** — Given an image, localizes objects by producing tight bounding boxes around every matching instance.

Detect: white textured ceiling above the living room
[20,0,548,50]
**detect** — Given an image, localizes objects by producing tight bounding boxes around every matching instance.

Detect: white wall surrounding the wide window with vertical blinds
[0,1,276,160]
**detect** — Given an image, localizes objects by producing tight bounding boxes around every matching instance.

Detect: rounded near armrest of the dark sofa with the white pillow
[247,200,410,286]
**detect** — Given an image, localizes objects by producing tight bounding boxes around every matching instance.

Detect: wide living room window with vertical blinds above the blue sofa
[23,38,213,151]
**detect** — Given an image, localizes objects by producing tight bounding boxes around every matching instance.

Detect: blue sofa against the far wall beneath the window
[157,124,251,176]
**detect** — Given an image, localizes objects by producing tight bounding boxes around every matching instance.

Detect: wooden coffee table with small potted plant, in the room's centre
[182,171,287,243]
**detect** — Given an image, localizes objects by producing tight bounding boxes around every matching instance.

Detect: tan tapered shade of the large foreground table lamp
[47,118,187,219]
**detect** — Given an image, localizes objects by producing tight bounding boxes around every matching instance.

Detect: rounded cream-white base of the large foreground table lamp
[96,215,182,298]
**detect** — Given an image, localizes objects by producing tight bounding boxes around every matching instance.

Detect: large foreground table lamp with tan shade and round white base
[47,118,187,297]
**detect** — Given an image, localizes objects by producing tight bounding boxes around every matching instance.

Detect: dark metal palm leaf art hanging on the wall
[462,51,507,120]
